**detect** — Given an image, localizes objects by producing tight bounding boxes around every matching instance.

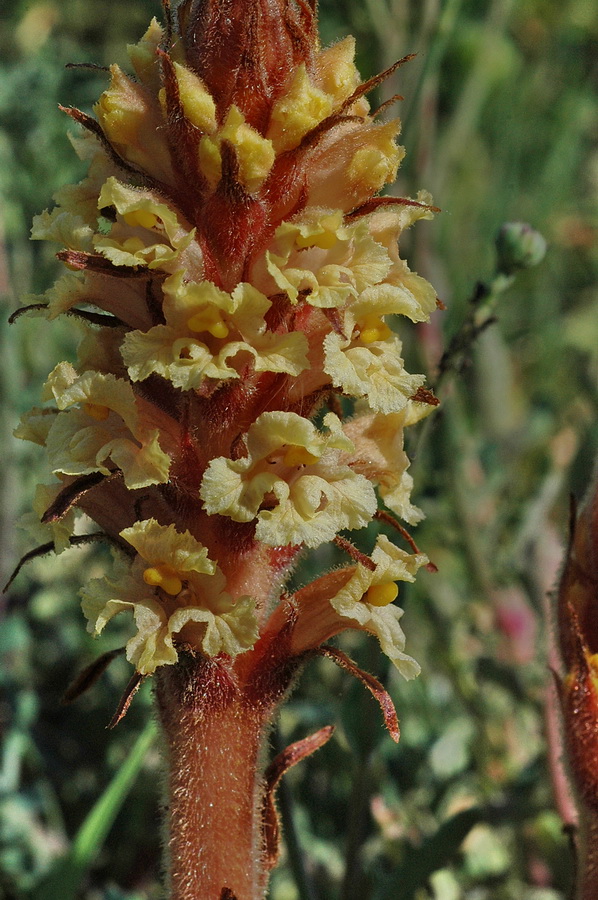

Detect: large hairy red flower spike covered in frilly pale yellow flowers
[13,0,437,900]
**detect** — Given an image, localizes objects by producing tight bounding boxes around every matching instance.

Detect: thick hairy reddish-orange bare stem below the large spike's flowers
[157,658,272,900]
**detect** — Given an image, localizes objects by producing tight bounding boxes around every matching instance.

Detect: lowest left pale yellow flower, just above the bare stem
[81,519,258,675]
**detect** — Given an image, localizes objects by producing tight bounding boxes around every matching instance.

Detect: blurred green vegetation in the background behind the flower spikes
[0,0,598,900]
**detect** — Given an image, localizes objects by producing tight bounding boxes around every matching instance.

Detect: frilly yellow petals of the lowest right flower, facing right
[330,535,428,678]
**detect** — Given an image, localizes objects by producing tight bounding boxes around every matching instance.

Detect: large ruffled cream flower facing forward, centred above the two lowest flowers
[200,412,376,547]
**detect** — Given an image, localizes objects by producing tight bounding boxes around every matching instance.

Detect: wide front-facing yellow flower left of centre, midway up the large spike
[121,273,308,390]
